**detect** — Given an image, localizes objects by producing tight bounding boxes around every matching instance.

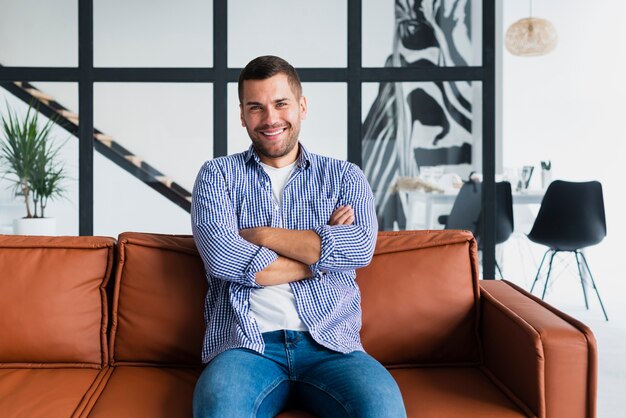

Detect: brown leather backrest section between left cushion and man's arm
[111,233,208,365]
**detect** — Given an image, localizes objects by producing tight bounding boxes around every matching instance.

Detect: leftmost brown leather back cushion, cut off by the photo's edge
[0,235,115,368]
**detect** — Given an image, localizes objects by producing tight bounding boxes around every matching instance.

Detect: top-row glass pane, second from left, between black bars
[94,0,213,67]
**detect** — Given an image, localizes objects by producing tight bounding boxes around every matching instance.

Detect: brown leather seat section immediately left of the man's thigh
[89,366,202,418]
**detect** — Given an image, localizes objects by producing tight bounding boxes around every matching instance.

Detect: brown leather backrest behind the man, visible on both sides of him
[110,230,479,366]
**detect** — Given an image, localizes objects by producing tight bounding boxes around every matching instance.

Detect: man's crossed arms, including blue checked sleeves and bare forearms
[191,160,377,287]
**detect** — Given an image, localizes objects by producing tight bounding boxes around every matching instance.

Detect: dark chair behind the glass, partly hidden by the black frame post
[438,181,513,277]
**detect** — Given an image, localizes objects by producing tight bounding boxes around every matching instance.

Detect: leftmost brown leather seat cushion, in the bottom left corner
[0,369,102,417]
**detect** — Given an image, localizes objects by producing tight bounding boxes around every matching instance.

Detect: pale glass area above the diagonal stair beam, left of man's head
[94,83,213,190]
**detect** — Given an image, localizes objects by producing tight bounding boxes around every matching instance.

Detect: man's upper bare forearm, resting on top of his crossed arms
[239,227,322,265]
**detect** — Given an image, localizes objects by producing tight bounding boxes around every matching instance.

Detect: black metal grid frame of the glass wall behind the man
[0,0,496,279]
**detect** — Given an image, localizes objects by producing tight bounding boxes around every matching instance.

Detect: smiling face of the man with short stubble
[239,74,306,167]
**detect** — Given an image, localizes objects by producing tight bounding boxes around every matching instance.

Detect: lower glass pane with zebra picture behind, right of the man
[362,81,482,229]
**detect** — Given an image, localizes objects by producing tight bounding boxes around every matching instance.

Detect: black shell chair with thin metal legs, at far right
[528,180,609,321]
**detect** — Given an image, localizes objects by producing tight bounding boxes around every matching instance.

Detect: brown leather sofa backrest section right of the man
[357,230,479,366]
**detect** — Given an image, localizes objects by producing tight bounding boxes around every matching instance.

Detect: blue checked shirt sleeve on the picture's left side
[191,161,278,288]
